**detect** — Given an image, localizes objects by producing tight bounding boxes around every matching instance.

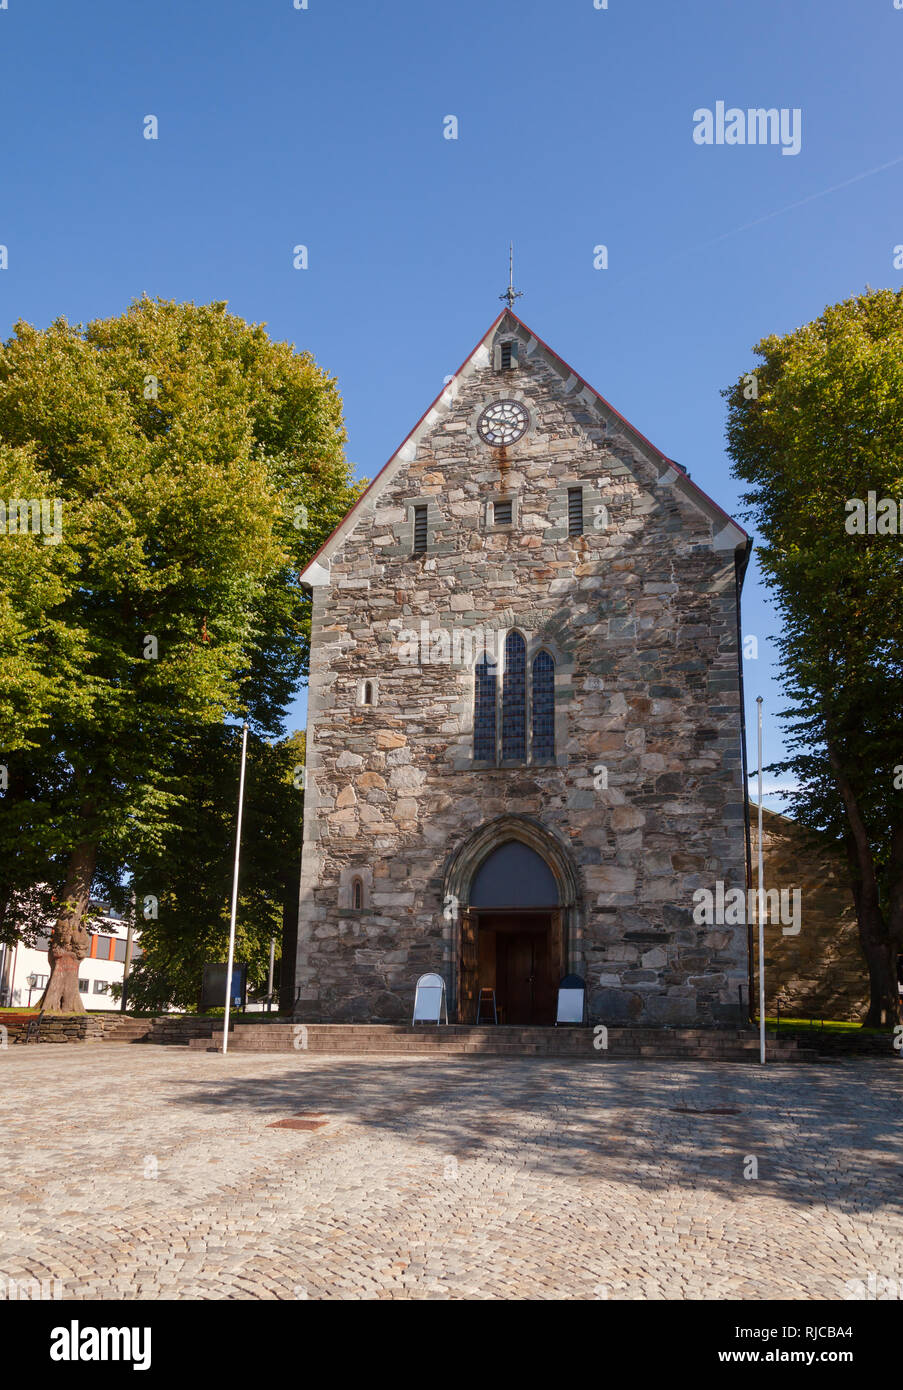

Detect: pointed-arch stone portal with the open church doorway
[443,816,582,1023]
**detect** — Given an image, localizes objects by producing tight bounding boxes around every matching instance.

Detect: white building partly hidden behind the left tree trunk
[0,904,142,1009]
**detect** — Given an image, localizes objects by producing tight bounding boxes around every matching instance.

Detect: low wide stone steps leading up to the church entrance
[175,1023,817,1063]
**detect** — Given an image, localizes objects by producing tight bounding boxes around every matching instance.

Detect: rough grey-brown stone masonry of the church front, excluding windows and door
[296,321,747,1024]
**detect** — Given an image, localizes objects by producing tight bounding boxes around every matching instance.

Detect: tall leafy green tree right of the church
[725,291,903,1026]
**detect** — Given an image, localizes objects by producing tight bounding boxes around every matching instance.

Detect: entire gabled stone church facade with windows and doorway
[295,309,750,1026]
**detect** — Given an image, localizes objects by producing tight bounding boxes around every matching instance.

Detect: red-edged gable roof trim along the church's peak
[300,307,752,588]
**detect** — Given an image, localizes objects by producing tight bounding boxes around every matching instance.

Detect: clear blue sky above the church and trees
[0,0,903,806]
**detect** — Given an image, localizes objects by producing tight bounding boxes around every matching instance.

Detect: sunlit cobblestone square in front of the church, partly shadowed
[0,1044,903,1300]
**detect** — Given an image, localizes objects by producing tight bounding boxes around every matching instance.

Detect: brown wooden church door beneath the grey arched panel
[458,909,564,1024]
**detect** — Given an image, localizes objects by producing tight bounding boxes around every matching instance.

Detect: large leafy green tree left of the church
[0,299,360,1011]
